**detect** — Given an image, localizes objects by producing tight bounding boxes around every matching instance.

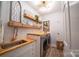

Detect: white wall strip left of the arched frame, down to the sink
[1,2,13,43]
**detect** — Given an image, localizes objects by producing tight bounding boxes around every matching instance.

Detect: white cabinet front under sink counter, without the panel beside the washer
[2,42,35,57]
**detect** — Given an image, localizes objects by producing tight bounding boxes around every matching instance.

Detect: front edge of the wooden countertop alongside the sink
[0,39,35,55]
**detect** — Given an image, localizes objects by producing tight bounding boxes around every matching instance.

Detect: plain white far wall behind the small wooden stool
[42,12,63,45]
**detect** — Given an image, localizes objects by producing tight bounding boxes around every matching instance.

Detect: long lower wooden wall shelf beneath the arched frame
[8,21,41,29]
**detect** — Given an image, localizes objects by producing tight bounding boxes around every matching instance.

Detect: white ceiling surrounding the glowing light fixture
[27,1,63,15]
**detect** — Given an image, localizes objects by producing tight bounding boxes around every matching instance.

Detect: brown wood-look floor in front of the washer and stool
[46,47,64,57]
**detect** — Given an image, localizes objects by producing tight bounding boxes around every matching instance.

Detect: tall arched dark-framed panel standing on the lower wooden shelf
[10,1,21,22]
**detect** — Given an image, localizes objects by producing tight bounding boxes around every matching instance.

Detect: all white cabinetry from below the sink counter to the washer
[1,35,40,57]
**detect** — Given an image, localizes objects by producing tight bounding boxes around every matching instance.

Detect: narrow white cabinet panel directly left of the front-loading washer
[31,35,40,57]
